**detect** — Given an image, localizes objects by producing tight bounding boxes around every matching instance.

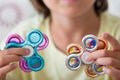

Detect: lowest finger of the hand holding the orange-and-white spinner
[103,67,120,80]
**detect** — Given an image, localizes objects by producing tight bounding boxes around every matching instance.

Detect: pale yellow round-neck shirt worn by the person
[0,13,120,80]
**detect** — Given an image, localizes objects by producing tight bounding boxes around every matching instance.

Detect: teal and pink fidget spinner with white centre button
[5,29,49,72]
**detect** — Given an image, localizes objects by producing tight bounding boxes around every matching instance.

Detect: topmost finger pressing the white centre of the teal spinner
[1,48,30,56]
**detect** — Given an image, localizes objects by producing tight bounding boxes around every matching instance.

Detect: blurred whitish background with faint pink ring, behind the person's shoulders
[0,0,120,42]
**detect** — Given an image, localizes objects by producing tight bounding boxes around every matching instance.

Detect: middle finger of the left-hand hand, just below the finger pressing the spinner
[0,55,21,67]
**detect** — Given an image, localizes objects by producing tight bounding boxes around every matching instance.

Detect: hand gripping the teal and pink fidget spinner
[0,48,29,80]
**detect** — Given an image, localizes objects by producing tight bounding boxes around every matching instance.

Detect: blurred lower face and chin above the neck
[43,0,95,16]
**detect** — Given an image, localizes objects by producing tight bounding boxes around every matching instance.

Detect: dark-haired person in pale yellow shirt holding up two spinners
[0,0,120,80]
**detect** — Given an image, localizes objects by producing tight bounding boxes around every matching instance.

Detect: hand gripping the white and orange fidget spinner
[86,33,120,80]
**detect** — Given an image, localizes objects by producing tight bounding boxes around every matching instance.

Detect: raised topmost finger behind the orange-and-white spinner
[102,33,120,50]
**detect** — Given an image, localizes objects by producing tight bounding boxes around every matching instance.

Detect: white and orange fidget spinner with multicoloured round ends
[66,35,108,78]
